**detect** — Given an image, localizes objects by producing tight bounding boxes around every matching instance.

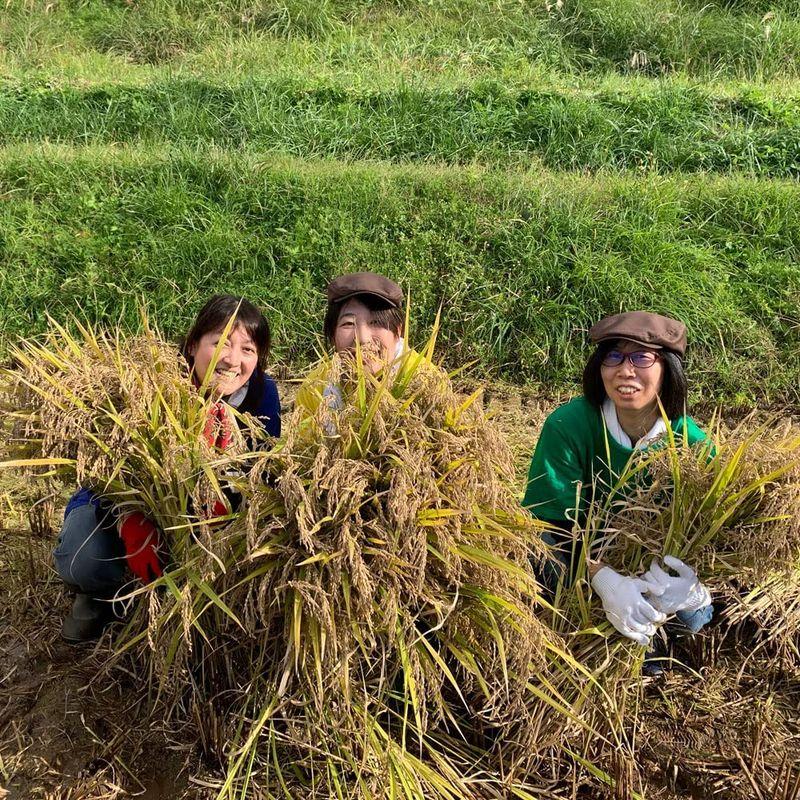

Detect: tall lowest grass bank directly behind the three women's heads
[0,142,800,404]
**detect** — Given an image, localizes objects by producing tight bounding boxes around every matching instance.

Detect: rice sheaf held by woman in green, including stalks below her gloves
[520,420,800,797]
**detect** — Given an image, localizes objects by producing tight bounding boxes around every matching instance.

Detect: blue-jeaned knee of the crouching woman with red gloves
[53,503,126,596]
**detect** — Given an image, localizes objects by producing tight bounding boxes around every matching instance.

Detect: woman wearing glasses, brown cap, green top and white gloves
[523,311,713,660]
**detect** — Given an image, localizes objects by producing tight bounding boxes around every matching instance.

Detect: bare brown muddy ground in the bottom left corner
[0,530,195,800]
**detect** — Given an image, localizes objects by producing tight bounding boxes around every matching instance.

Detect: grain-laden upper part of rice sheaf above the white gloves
[598,419,800,664]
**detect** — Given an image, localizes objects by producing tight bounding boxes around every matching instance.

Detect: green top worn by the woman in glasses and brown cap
[522,397,706,523]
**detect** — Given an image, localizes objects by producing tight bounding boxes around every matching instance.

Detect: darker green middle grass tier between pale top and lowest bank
[0,80,800,176]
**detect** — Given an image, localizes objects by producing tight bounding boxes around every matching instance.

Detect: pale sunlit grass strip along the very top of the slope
[0,0,800,79]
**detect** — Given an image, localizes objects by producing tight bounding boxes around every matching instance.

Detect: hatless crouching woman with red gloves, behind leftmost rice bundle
[53,295,281,643]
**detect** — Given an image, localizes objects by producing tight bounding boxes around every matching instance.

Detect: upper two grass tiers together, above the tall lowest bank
[0,0,800,177]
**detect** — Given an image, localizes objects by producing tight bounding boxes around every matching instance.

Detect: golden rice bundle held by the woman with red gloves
[0,323,263,565]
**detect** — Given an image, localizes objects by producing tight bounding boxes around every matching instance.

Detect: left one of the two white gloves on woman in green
[592,567,667,646]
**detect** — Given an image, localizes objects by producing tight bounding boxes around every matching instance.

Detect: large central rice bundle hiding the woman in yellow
[141,351,563,798]
